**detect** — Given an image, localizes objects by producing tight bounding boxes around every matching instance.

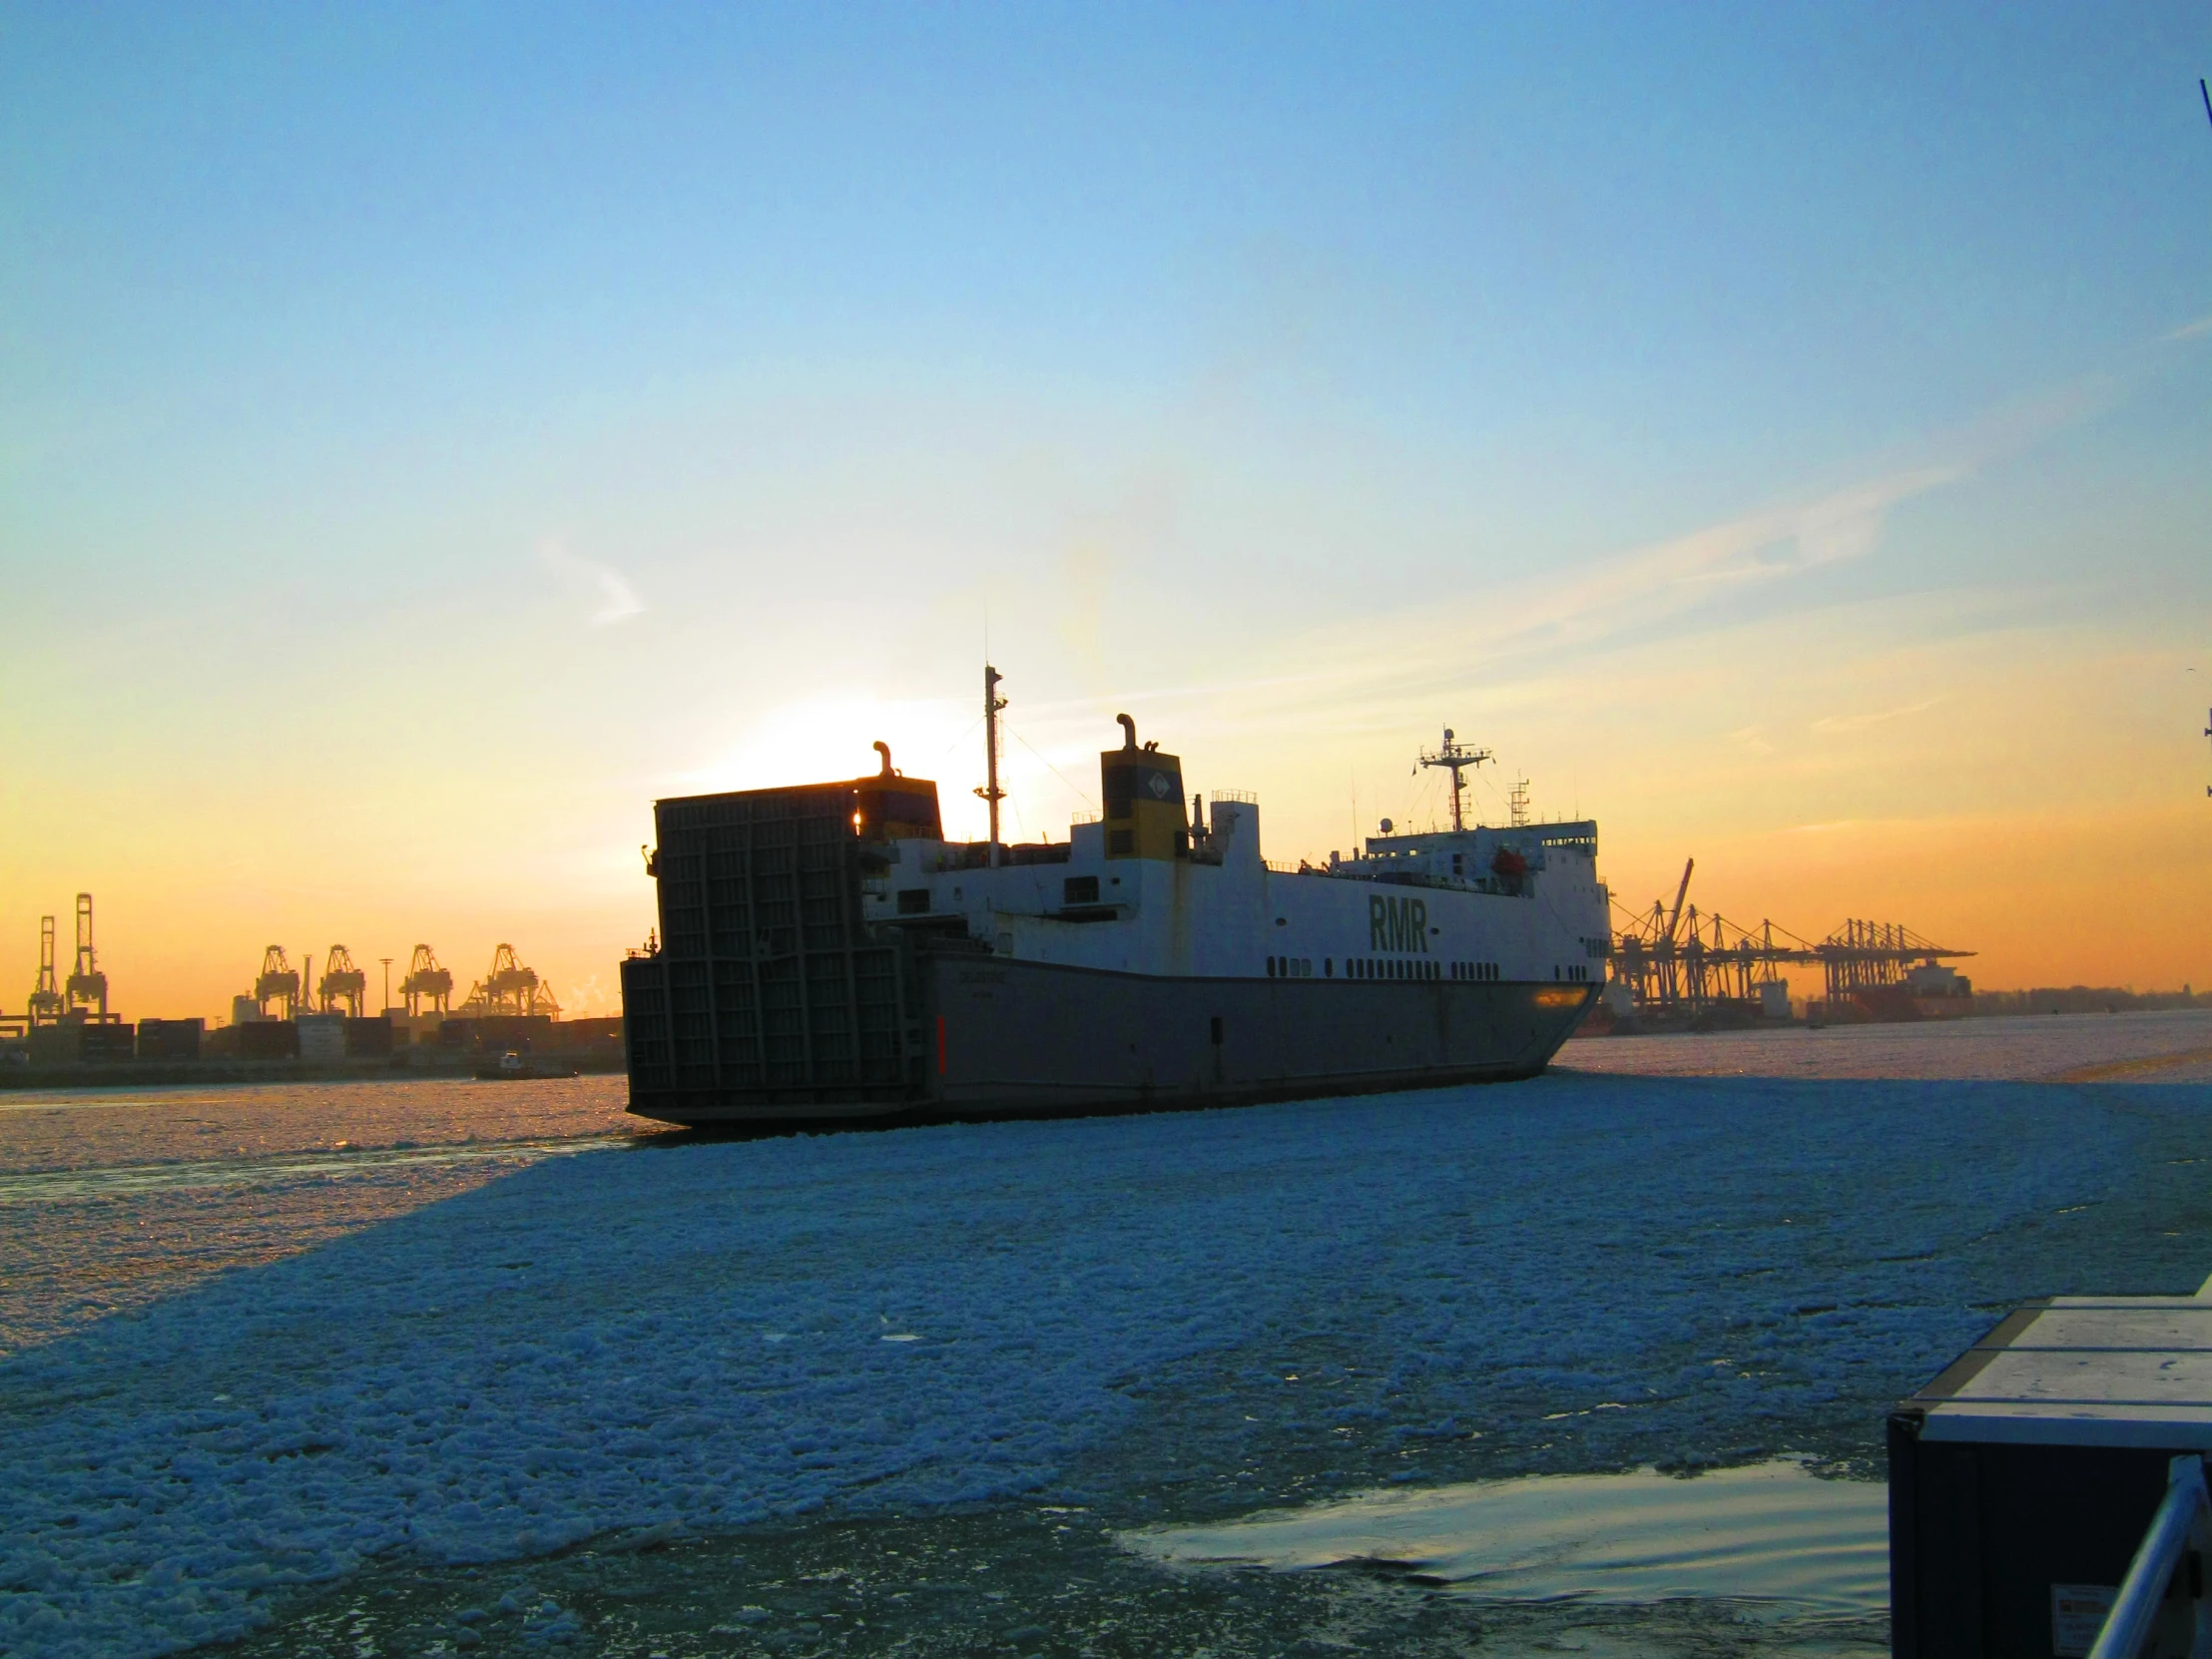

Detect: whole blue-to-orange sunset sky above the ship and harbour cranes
[13,4,2212,1017]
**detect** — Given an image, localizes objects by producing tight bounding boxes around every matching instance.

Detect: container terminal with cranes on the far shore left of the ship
[0,893,622,1088]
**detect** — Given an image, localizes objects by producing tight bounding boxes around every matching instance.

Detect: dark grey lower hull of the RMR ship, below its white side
[631,955,1597,1124]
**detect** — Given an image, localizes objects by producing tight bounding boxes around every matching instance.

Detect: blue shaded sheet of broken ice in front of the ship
[0,1021,2212,1655]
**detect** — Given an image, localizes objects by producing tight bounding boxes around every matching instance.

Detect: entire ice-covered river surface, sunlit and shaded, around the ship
[0,1013,2212,1659]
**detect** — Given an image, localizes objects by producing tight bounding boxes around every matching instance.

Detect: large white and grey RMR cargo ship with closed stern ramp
[622,668,1608,1126]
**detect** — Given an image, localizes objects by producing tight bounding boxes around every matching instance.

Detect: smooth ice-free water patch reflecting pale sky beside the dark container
[1124,1460,1889,1615]
